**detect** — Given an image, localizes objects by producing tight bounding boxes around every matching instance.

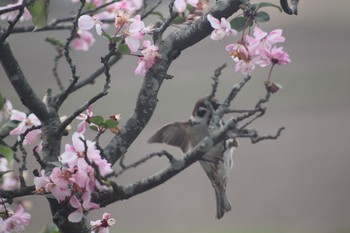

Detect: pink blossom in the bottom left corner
[0,205,30,232]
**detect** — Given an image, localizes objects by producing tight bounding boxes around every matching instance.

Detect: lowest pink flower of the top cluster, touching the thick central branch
[135,40,160,75]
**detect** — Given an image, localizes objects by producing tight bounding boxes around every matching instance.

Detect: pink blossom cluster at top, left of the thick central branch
[73,0,160,75]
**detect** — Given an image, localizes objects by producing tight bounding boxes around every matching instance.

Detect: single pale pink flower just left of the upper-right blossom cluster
[207,14,237,40]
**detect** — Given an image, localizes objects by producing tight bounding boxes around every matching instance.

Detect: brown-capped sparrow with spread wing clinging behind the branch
[148,98,238,219]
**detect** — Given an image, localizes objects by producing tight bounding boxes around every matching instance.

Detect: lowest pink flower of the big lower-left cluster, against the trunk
[68,192,100,222]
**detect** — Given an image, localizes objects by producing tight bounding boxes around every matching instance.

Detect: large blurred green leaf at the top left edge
[27,0,50,28]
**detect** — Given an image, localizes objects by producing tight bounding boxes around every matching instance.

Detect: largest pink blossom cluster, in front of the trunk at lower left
[34,132,113,222]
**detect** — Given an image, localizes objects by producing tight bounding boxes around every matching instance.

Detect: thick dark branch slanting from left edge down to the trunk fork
[0,42,49,122]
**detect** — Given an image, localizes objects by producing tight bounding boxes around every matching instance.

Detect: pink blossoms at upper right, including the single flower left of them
[207,14,291,78]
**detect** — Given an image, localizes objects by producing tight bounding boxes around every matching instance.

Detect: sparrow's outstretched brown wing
[148,122,192,153]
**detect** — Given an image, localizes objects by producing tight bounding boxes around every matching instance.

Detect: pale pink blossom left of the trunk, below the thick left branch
[10,110,41,145]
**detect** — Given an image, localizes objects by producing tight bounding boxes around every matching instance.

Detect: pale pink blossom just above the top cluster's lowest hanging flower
[124,15,145,52]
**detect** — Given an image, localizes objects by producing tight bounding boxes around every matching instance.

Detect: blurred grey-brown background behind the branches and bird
[0,0,350,233]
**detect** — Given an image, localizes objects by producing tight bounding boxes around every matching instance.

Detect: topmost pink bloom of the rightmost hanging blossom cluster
[246,27,285,55]
